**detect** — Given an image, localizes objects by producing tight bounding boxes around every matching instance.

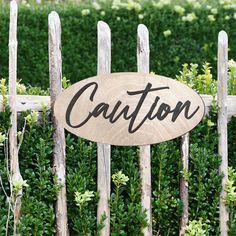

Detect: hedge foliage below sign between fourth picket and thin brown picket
[151,140,182,235]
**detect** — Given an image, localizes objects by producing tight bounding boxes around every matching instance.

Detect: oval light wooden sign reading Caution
[54,73,204,146]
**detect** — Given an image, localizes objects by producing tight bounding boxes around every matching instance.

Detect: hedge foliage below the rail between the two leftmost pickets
[15,111,59,235]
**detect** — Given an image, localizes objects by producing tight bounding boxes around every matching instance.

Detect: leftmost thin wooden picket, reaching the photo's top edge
[9,0,22,235]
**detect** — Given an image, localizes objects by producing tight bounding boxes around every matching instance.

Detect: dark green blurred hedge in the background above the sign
[0,3,236,88]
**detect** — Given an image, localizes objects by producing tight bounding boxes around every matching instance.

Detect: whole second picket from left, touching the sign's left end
[48,12,68,236]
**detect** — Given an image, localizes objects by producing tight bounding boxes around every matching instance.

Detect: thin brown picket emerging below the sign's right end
[179,133,189,236]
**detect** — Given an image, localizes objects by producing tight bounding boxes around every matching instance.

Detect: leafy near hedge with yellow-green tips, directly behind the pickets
[0,61,236,236]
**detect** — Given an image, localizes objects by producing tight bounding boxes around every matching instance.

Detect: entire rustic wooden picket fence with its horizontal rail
[0,1,236,236]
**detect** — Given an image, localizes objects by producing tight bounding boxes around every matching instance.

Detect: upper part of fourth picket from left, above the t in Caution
[137,24,150,73]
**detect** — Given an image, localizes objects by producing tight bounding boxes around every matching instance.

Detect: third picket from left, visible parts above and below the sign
[97,21,111,236]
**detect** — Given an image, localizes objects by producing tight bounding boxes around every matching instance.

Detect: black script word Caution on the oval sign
[66,82,200,133]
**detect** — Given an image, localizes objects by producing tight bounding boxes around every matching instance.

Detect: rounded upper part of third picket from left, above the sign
[97,21,111,74]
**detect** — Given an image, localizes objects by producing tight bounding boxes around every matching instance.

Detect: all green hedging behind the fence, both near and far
[0,1,236,236]
